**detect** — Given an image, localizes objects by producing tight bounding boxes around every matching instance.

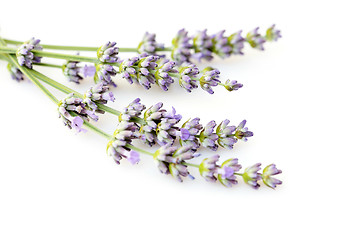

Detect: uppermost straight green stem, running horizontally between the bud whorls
[4,39,172,52]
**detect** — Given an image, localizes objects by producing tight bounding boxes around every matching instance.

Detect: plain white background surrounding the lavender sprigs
[0,0,360,240]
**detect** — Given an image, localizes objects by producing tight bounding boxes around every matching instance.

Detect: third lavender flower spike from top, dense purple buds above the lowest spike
[112,98,253,152]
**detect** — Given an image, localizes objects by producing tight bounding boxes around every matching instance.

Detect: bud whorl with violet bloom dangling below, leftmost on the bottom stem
[58,93,98,132]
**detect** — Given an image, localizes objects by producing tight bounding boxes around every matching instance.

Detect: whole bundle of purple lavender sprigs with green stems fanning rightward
[0,25,282,189]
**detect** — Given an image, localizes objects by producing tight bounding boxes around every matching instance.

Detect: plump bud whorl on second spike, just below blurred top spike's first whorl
[119,53,159,89]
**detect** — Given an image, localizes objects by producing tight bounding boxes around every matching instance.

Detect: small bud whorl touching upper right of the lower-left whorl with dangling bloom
[84,82,115,113]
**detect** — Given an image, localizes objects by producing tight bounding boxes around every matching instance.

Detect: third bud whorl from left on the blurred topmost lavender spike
[192,29,213,62]
